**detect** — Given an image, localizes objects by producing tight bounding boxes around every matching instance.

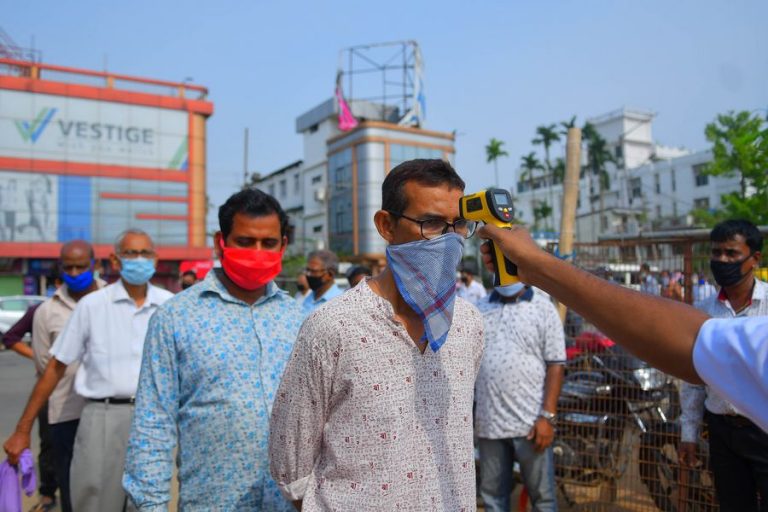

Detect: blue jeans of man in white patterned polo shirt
[478,437,557,512]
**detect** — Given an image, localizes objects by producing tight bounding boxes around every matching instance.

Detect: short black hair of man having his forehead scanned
[381,158,465,213]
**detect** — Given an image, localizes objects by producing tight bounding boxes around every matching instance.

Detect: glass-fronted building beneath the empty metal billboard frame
[255,98,455,266]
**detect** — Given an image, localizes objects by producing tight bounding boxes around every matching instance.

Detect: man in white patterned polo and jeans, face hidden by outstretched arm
[475,283,566,512]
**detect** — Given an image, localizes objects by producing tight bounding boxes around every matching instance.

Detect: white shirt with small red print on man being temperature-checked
[269,281,483,512]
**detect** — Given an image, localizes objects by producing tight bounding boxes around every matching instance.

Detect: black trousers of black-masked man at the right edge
[706,412,768,512]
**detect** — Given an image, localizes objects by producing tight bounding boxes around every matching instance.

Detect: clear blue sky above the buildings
[0,0,768,228]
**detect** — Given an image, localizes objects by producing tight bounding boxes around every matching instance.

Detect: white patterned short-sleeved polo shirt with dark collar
[475,288,566,439]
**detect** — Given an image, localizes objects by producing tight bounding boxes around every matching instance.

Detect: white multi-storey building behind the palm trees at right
[515,109,739,242]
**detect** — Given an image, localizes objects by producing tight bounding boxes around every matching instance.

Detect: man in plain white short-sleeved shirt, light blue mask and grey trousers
[3,229,172,512]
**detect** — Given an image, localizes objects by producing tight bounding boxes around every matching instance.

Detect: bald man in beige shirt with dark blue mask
[26,240,106,512]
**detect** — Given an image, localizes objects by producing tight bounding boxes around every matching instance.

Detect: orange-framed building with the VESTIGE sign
[0,59,213,295]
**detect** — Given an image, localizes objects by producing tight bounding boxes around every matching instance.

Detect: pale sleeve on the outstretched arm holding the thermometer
[693,316,768,432]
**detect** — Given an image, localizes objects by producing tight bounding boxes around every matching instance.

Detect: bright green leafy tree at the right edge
[694,111,768,225]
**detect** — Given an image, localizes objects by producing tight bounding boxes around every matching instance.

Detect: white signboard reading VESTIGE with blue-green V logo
[0,90,189,170]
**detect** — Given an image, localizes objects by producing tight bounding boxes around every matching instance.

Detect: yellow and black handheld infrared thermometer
[459,188,520,286]
